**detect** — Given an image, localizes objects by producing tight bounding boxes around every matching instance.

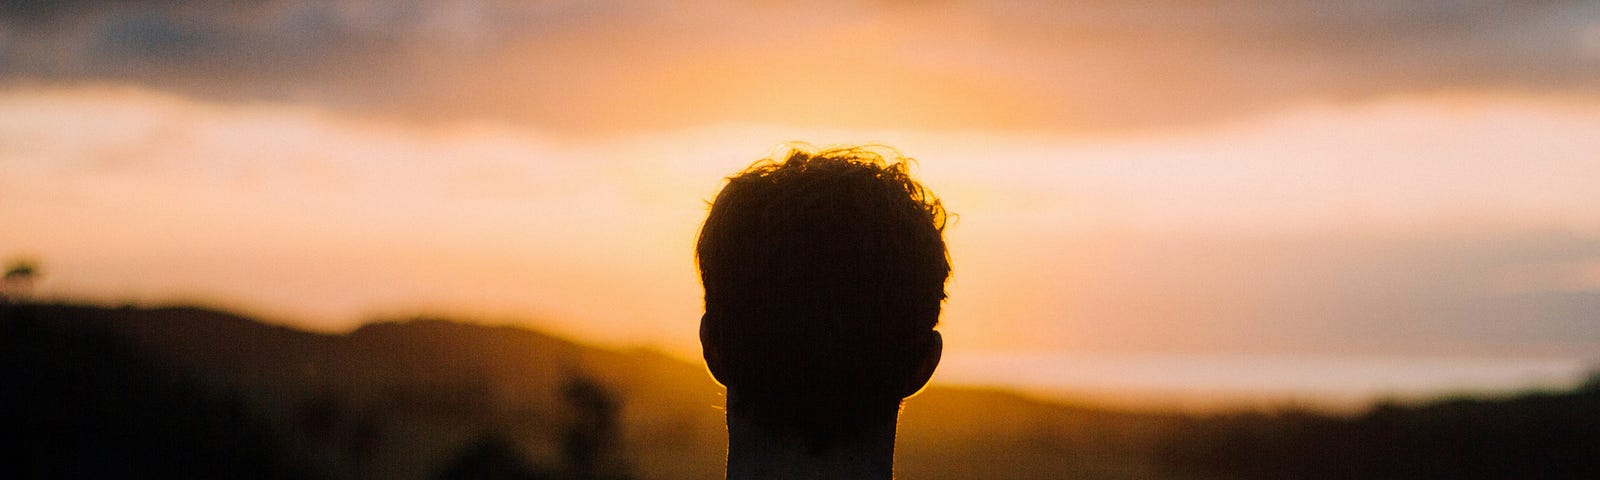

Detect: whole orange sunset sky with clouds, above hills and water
[0,0,1600,401]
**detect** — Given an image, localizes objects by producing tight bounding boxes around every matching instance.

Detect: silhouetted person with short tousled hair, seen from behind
[696,149,950,478]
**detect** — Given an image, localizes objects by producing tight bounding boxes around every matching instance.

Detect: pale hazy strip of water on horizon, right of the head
[936,354,1600,410]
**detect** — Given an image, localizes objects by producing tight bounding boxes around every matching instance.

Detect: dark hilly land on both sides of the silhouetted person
[0,306,1600,478]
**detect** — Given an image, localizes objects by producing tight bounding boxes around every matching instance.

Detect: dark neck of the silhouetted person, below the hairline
[728,403,898,480]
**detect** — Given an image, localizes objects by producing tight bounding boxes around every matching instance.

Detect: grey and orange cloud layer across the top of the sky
[0,0,1600,131]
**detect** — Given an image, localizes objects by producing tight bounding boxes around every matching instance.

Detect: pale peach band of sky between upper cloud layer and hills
[0,88,1600,366]
